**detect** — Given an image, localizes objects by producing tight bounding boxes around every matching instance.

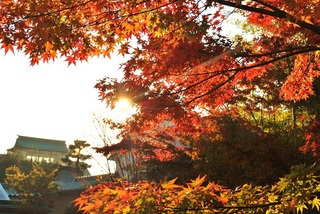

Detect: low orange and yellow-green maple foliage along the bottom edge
[76,165,320,213]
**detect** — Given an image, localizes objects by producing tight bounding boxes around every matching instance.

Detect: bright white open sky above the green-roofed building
[0,50,124,174]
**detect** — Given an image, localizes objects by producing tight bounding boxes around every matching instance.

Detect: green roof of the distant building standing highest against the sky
[15,136,68,153]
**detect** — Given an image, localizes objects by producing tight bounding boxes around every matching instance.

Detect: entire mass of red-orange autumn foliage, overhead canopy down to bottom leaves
[0,0,320,213]
